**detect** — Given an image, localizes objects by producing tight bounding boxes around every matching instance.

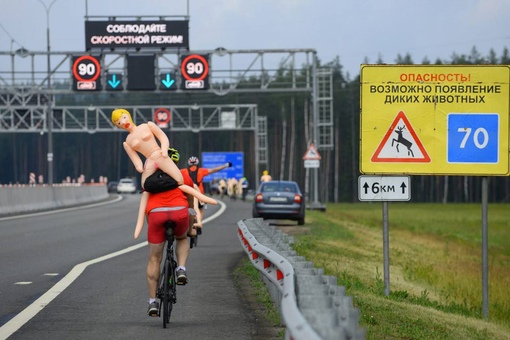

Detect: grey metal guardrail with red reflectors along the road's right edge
[238,218,366,340]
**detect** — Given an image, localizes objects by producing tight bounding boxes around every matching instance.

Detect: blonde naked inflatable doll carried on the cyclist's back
[112,109,217,204]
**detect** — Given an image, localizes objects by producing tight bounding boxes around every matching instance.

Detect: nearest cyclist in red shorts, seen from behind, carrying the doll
[134,150,196,316]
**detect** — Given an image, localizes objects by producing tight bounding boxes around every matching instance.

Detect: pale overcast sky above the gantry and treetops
[0,0,510,77]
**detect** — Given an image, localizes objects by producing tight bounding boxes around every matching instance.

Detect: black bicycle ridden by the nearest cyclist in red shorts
[156,221,177,328]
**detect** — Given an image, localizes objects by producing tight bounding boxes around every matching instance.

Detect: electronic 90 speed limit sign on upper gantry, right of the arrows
[181,54,209,90]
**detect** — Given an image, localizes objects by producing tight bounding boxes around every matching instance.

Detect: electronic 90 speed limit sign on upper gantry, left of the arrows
[72,55,101,91]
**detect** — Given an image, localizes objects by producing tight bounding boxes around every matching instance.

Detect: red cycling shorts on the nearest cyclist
[147,207,189,244]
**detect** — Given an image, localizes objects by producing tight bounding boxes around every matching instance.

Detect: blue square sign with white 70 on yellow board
[447,113,499,163]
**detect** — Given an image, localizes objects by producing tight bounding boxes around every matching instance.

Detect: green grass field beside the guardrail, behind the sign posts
[294,203,510,339]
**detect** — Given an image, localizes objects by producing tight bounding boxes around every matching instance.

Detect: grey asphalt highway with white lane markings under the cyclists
[0,194,272,339]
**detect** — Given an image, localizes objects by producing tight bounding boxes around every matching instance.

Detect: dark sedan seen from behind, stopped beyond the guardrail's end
[252,181,305,225]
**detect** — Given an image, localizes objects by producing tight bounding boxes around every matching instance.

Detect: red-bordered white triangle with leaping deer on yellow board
[371,111,430,163]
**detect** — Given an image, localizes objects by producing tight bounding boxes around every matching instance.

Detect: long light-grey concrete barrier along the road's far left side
[0,184,109,216]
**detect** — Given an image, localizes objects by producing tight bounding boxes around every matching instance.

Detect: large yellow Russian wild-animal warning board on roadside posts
[360,65,510,175]
